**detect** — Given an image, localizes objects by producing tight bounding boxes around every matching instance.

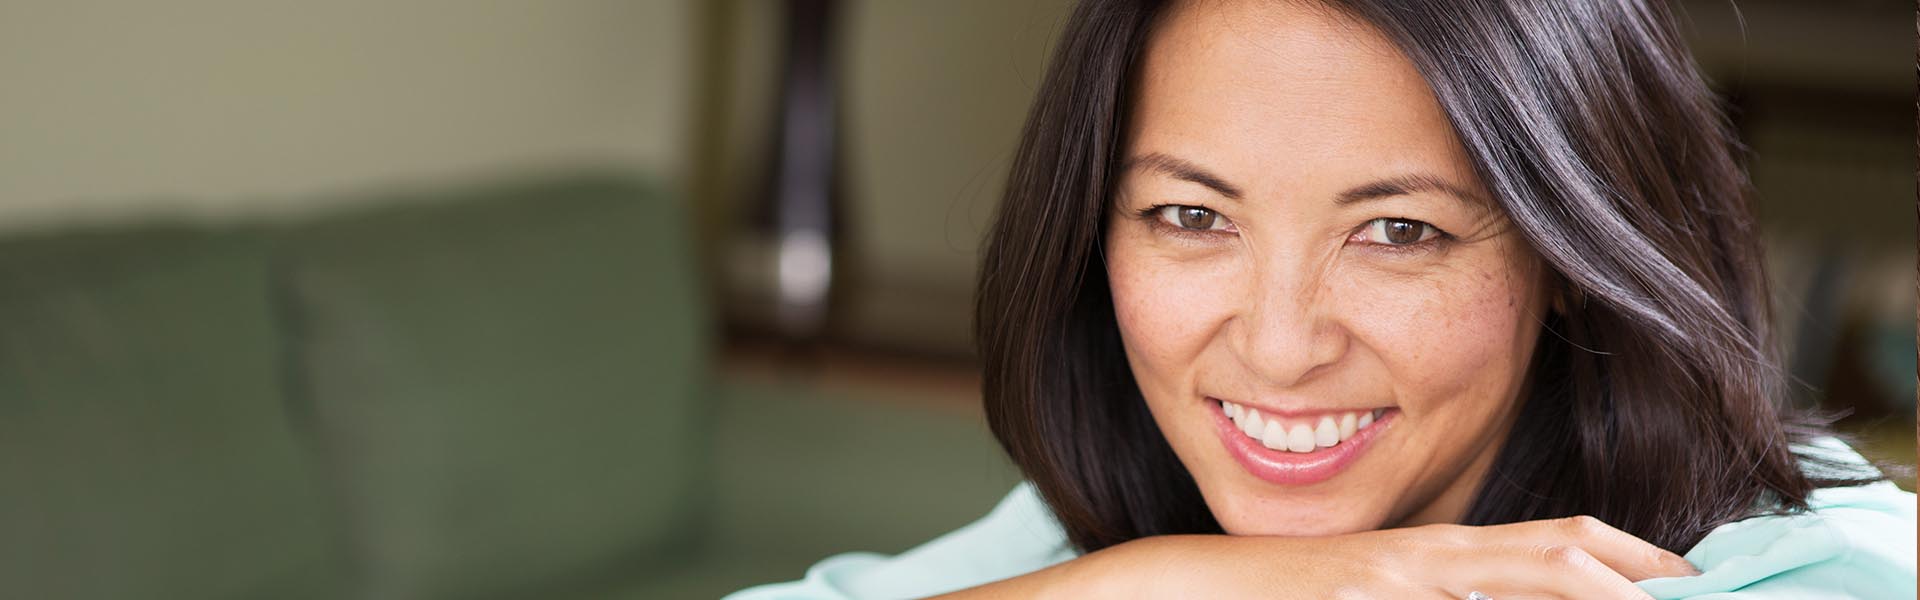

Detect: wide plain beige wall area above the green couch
[0,0,693,229]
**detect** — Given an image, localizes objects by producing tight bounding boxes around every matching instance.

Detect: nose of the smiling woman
[1229,260,1348,388]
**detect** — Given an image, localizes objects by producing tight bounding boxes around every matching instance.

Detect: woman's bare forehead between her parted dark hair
[1129,0,1473,194]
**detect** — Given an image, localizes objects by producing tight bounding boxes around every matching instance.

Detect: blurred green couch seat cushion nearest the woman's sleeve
[595,378,1020,598]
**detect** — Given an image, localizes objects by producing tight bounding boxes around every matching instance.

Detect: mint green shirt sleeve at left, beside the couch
[726,483,1075,600]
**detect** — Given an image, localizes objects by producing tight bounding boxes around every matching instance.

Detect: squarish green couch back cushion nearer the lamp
[284,179,707,598]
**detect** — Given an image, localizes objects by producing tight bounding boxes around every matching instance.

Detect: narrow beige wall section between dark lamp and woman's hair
[845,0,1071,352]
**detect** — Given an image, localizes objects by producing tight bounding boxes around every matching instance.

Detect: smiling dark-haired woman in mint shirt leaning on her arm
[735,0,1914,598]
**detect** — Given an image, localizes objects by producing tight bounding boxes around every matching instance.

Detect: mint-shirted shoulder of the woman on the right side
[1640,442,1914,598]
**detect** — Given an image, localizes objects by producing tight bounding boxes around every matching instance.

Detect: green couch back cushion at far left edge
[0,229,334,598]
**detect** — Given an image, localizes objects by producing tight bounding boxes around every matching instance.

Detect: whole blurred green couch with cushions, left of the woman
[0,175,1016,598]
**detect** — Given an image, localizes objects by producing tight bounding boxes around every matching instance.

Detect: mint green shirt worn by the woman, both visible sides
[728,440,1914,600]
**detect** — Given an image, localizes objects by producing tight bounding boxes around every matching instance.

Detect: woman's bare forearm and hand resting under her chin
[940,517,1697,600]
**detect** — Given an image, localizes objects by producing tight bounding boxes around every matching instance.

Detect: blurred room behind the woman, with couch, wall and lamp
[0,0,1916,598]
